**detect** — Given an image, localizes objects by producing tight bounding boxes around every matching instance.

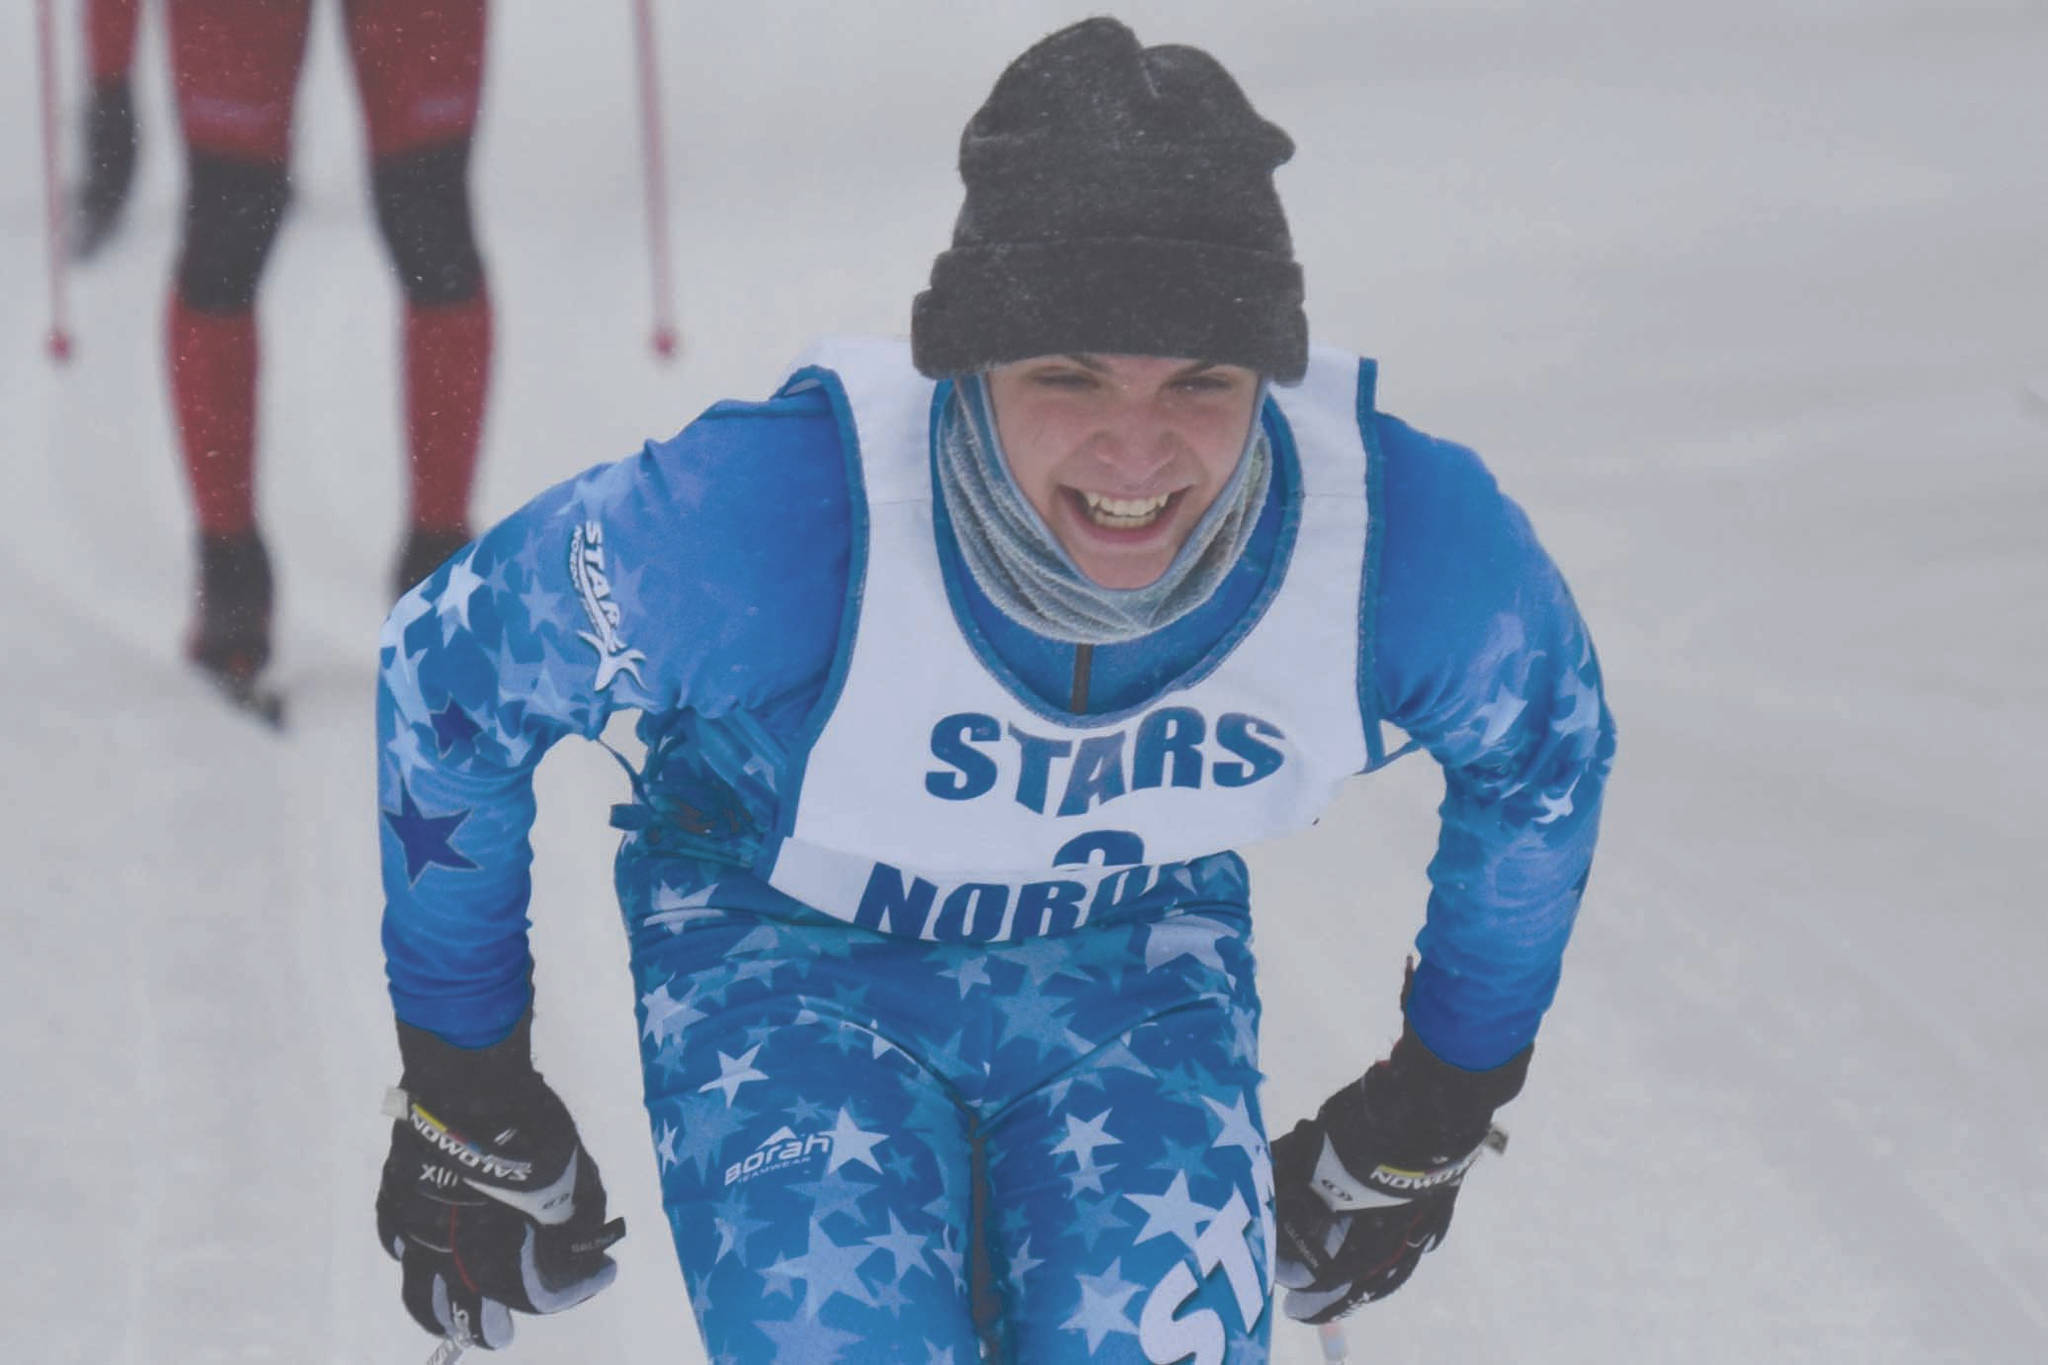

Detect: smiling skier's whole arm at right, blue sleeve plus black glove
[1272,420,1614,1322]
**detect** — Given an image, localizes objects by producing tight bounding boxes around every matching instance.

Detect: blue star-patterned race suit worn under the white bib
[377,347,1614,1365]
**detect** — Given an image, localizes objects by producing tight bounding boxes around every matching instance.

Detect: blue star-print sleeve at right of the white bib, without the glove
[1374,417,1614,1070]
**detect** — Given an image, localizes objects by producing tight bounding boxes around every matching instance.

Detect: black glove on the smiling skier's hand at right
[1274,1031,1534,1322]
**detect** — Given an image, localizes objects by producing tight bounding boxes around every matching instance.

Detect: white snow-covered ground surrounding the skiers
[0,0,2048,1365]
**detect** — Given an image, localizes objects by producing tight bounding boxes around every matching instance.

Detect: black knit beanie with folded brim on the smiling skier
[911,18,1309,383]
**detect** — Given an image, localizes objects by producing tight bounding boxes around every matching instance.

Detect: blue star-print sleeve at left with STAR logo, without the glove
[377,388,848,1046]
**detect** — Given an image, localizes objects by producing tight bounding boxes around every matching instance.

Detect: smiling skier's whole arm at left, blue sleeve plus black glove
[377,388,850,1347]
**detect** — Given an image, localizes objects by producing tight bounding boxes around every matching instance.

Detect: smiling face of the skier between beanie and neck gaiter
[989,354,1260,587]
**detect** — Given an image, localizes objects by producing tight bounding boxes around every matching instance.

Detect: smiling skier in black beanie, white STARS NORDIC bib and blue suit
[377,18,1614,1365]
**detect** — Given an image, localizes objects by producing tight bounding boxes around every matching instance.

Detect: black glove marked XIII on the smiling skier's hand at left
[377,1015,627,1349]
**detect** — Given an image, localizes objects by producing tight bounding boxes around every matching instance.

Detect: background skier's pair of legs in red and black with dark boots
[166,0,492,716]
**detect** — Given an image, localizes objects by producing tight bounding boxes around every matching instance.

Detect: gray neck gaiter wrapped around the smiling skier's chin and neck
[938,375,1272,645]
